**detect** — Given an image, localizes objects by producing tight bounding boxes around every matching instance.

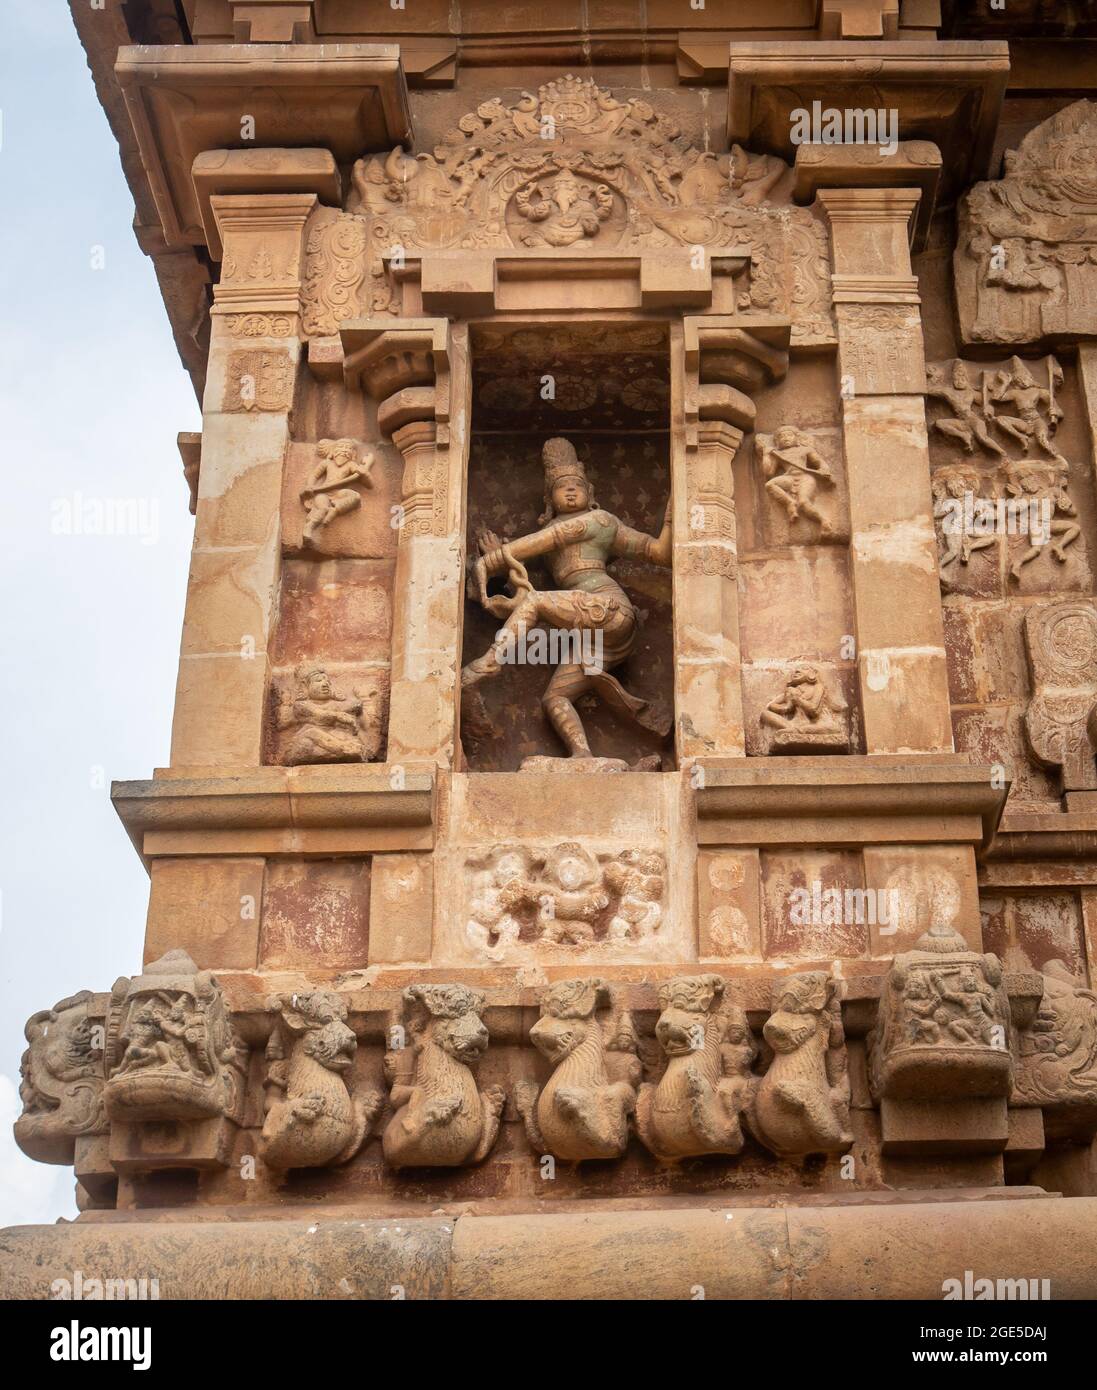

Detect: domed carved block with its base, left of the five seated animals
[103,951,247,1172]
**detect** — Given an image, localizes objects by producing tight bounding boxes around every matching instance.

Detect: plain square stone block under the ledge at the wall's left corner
[145,858,264,970]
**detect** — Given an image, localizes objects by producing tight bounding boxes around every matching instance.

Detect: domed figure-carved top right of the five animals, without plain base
[869,926,1012,1101]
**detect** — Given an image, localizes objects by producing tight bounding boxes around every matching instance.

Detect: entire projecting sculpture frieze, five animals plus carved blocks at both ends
[29,926,1097,1172]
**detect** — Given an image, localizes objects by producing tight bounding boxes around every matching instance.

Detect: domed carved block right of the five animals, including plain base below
[869,926,1014,1155]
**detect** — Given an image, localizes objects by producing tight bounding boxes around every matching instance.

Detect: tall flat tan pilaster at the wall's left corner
[171,190,317,767]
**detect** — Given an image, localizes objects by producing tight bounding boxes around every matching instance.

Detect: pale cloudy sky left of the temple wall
[0,0,200,1226]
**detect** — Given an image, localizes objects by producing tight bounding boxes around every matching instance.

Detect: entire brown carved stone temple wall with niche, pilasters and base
[8,0,1097,1298]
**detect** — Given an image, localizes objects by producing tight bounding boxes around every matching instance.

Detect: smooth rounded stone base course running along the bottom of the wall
[0,1190,1097,1301]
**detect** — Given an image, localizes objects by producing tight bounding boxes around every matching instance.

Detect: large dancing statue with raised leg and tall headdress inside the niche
[462,439,670,767]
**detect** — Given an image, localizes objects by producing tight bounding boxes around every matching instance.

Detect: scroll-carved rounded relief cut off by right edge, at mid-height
[1025,600,1097,792]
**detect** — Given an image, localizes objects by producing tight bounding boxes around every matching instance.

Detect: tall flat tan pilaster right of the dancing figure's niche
[819,188,952,753]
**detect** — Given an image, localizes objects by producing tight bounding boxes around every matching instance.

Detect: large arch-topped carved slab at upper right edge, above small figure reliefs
[954,101,1097,345]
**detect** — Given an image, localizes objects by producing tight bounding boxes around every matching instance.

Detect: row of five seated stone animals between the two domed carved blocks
[260,972,852,1169]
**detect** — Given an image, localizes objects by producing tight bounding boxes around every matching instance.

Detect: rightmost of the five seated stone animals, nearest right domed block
[749,970,854,1158]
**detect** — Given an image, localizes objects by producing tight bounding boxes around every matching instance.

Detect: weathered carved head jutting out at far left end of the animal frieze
[15,990,107,1163]
